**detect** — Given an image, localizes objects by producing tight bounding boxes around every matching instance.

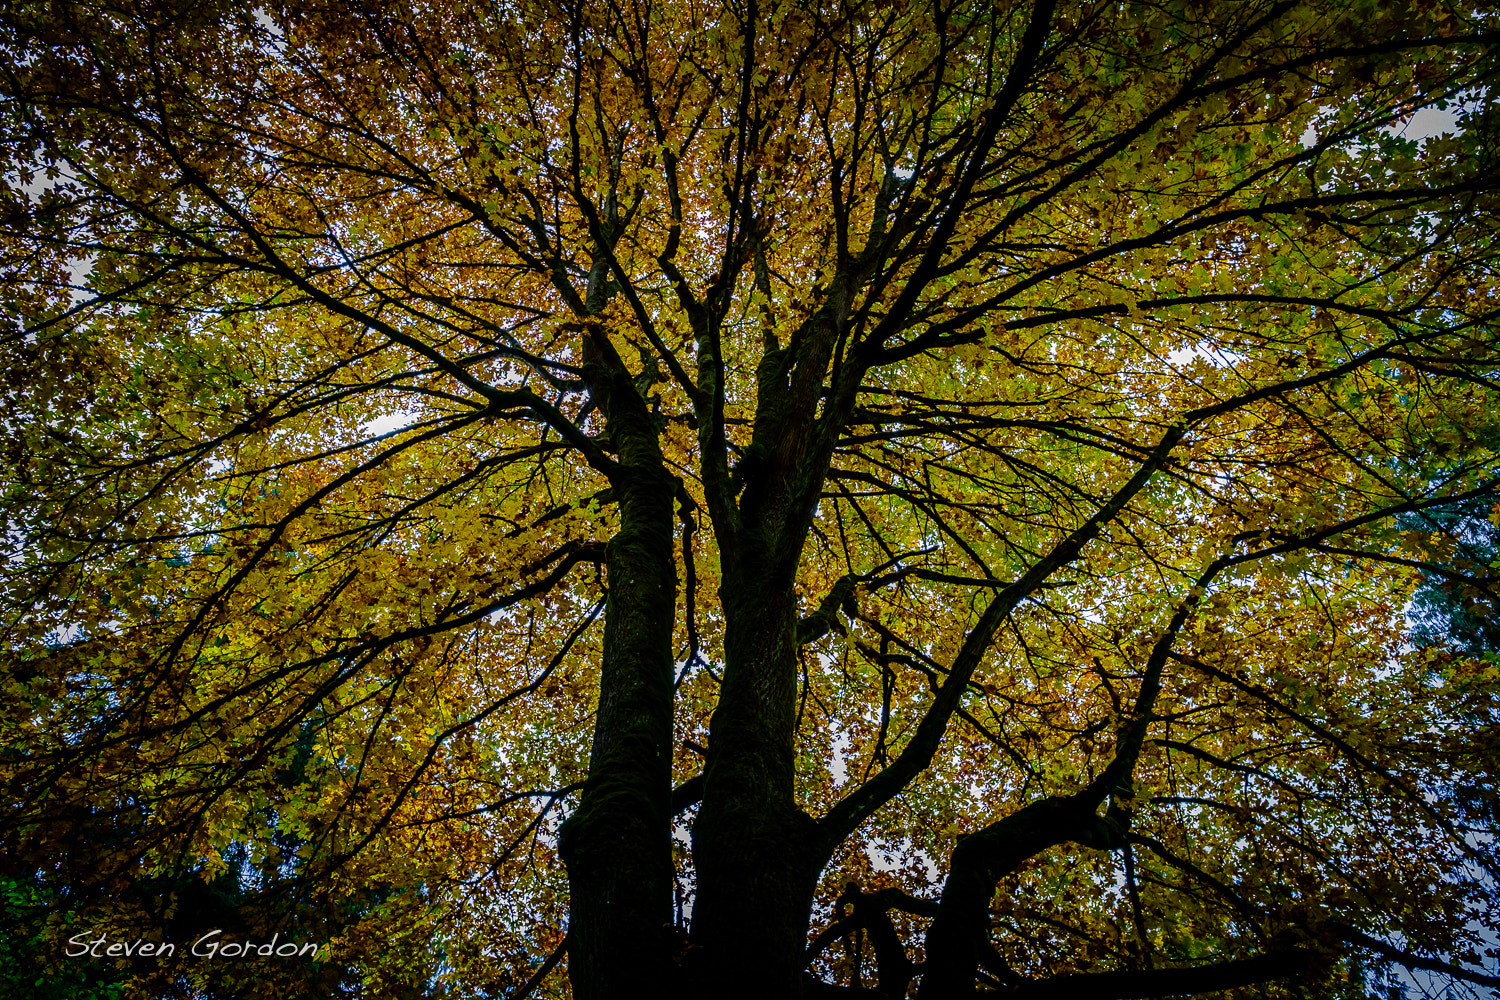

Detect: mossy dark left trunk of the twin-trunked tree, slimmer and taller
[560,385,677,1000]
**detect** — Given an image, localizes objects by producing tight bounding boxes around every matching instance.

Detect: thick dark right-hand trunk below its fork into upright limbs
[693,577,818,1000]
